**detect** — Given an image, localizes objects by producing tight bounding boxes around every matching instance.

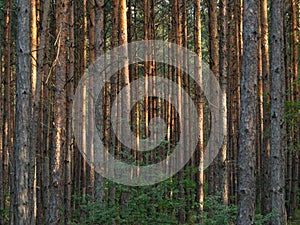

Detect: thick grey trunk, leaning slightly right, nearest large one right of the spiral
[237,0,258,225]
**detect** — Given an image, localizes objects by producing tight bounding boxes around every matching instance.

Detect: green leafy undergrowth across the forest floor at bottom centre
[70,170,271,225]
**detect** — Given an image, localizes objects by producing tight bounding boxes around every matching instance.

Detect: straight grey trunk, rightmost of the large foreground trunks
[270,0,287,225]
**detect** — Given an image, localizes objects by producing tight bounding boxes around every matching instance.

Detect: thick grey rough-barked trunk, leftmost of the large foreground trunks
[13,0,31,225]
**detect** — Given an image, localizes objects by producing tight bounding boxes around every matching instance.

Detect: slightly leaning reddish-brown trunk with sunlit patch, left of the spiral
[48,0,69,224]
